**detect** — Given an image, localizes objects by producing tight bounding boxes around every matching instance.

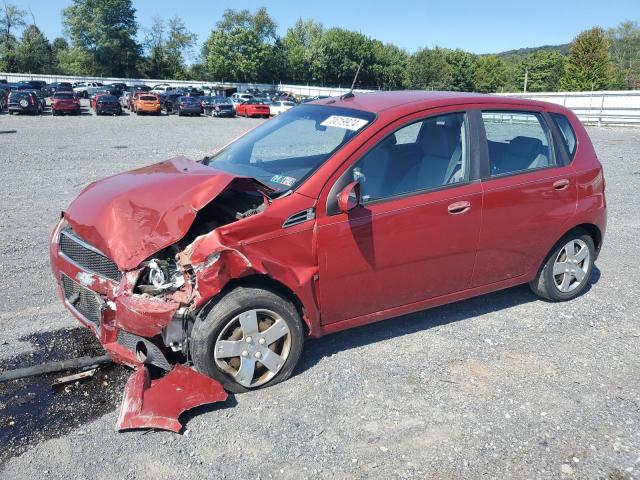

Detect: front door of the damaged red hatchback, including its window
[317,112,482,324]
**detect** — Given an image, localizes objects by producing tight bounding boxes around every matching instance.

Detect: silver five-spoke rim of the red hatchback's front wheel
[214,309,291,388]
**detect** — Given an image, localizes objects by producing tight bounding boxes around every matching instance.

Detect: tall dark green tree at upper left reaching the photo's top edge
[62,0,141,77]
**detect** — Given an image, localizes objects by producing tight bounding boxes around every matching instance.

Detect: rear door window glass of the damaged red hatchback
[482,111,553,177]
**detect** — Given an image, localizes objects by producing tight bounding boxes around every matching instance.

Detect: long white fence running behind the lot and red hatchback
[0,72,640,125]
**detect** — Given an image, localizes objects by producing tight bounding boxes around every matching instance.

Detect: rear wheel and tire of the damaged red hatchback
[529,229,596,302]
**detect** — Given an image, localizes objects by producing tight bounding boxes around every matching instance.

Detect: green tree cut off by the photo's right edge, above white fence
[607,21,640,89]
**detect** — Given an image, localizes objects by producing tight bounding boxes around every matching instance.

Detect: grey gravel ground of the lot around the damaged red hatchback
[0,102,640,480]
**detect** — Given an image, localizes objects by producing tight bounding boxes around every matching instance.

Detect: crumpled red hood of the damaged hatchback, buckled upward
[64,157,270,270]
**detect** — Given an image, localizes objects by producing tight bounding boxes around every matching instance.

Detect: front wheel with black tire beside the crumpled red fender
[191,287,304,393]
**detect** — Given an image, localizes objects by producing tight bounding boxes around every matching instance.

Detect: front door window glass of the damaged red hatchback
[347,113,469,203]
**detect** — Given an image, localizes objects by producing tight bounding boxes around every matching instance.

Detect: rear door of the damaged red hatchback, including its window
[472,111,577,286]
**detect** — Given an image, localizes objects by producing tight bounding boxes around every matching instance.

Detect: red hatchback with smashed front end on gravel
[50,91,606,392]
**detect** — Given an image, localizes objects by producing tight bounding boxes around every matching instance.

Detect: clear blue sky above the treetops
[9,0,640,53]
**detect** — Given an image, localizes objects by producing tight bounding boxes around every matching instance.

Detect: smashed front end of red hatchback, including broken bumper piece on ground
[50,157,278,431]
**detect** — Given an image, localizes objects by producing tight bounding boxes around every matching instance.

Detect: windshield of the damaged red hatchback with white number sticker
[205,105,375,192]
